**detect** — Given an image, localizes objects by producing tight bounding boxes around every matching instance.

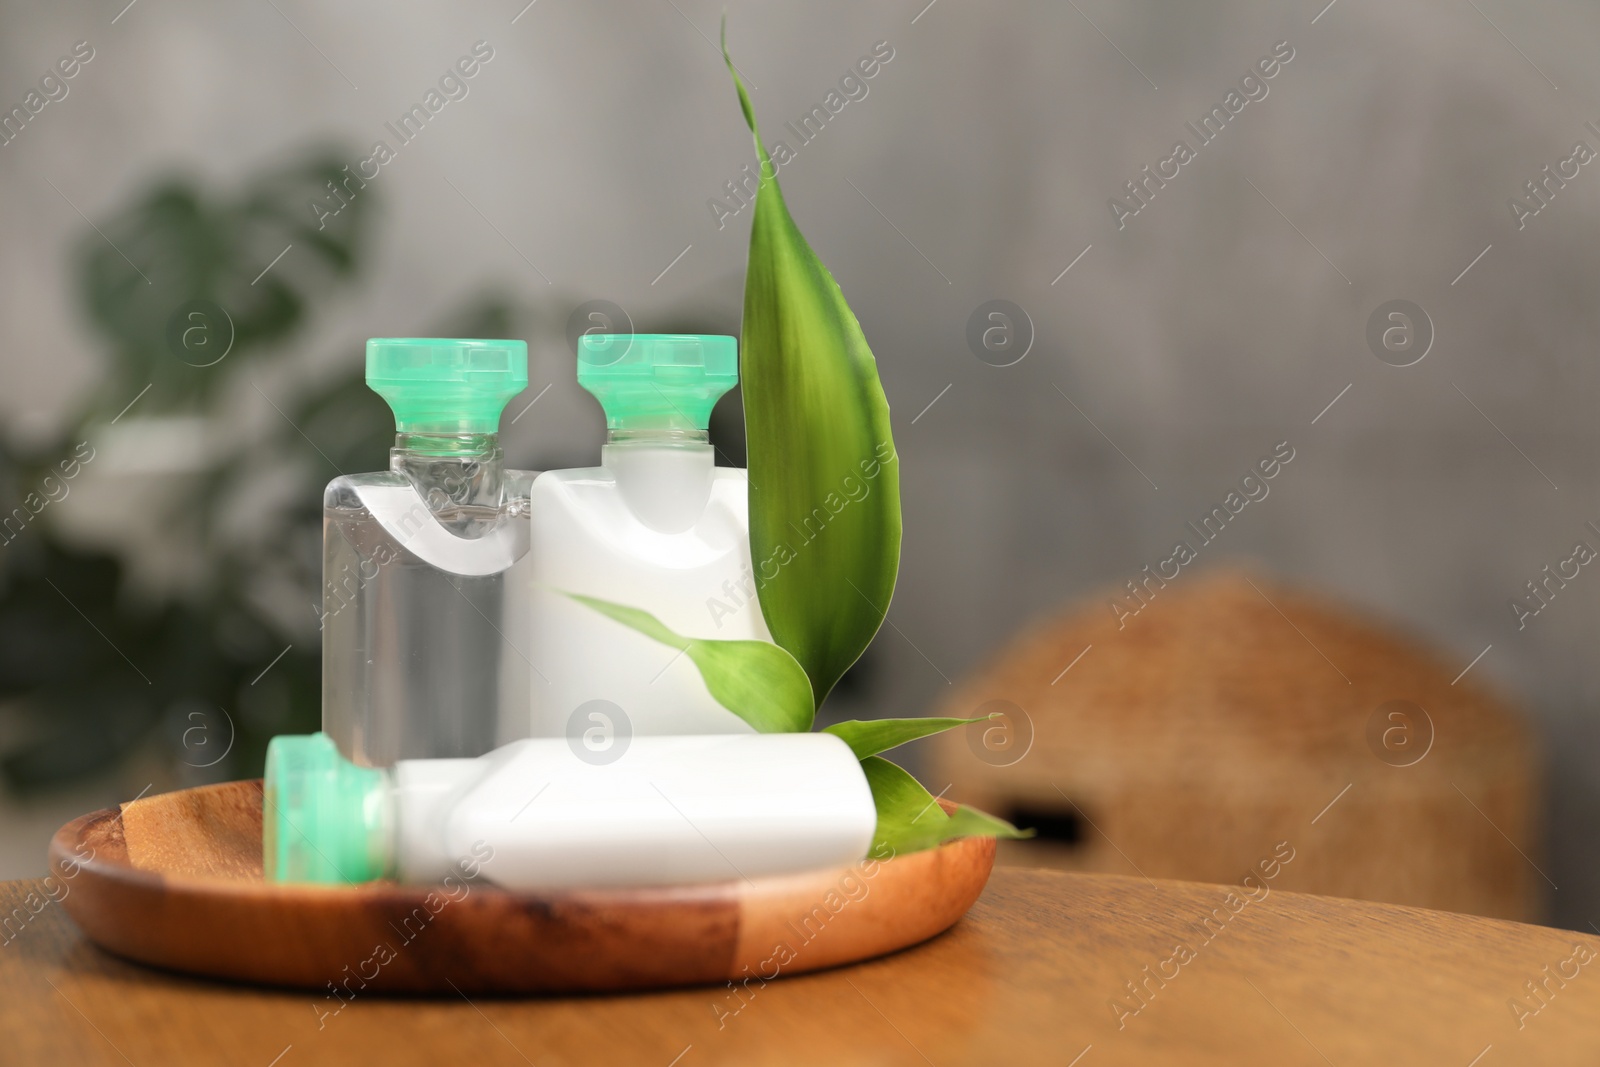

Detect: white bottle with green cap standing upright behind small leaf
[528,334,771,750]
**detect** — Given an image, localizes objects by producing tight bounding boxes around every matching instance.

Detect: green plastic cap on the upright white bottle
[578,333,739,430]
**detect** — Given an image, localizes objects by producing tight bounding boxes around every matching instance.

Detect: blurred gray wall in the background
[0,0,1600,926]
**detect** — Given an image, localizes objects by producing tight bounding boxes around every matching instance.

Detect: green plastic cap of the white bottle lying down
[261,734,392,885]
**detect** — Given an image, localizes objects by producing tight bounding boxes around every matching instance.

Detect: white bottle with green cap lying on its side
[262,733,877,891]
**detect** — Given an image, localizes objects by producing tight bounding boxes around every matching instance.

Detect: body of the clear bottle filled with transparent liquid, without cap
[322,450,534,766]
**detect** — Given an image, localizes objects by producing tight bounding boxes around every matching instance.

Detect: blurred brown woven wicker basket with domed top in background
[923,569,1550,920]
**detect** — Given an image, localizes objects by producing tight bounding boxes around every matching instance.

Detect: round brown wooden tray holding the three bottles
[50,779,995,1000]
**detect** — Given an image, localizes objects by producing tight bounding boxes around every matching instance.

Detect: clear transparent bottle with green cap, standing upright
[322,338,534,766]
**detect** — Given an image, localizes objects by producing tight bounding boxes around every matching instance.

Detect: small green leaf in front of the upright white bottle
[566,593,816,734]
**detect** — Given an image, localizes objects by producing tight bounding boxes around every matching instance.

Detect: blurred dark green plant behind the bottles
[0,152,514,789]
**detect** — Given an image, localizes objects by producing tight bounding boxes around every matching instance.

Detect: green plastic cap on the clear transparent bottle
[366,338,528,434]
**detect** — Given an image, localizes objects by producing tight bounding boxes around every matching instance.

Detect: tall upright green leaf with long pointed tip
[723,22,901,705]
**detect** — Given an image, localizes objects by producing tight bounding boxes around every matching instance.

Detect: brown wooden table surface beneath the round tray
[0,869,1600,1067]
